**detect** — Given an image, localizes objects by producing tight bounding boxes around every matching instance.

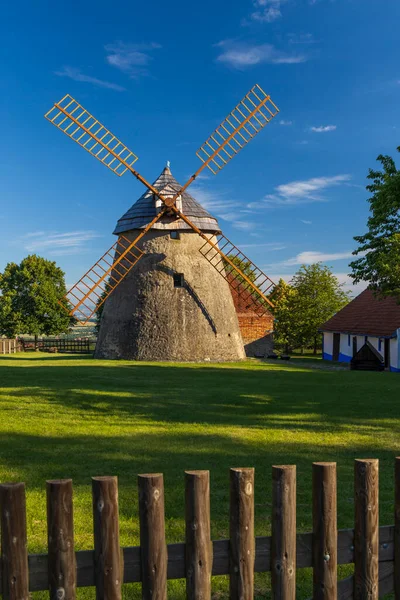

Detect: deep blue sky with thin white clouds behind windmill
[0,0,400,296]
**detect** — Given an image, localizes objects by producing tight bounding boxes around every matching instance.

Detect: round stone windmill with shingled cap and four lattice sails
[45,85,279,360]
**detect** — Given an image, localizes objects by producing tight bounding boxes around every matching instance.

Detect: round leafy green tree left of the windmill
[0,254,75,342]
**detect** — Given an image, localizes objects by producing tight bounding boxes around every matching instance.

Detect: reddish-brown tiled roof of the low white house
[321,289,400,337]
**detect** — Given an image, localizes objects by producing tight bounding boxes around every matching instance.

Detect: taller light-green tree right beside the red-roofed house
[290,263,350,354]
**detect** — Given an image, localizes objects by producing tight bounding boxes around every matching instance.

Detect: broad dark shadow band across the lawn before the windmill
[0,356,400,428]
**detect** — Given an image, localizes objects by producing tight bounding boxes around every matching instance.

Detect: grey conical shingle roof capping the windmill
[113,167,221,235]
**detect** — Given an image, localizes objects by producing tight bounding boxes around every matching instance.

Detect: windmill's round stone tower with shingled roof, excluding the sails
[95,169,245,361]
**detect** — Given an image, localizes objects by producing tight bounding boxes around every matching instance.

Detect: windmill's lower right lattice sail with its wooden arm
[170,207,275,316]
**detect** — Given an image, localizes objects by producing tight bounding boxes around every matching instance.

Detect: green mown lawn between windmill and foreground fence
[0,354,400,598]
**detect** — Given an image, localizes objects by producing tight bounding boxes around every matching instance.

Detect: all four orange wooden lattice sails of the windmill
[45,85,279,332]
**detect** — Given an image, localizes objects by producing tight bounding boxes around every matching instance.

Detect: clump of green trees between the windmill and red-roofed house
[273,263,349,353]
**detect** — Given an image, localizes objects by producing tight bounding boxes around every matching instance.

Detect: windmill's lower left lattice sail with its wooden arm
[60,209,166,325]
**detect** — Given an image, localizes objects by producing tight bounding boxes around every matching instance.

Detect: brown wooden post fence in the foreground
[0,458,400,600]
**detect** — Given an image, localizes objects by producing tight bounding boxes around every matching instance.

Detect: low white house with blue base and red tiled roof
[321,289,400,372]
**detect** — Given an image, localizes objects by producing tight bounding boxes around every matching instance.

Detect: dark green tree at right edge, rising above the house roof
[350,146,400,301]
